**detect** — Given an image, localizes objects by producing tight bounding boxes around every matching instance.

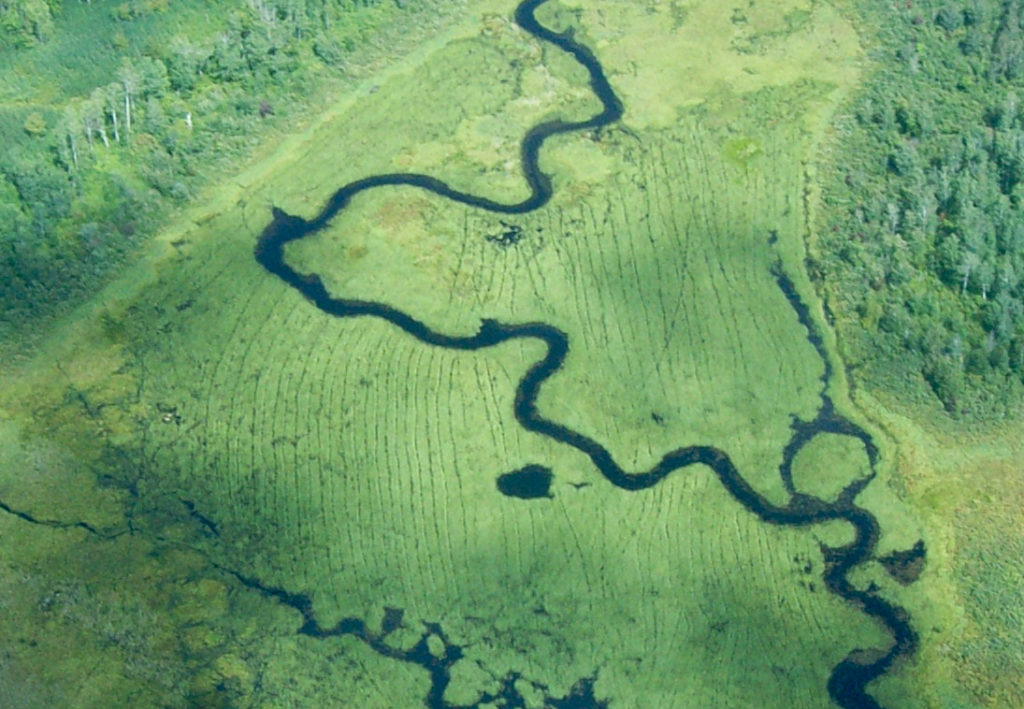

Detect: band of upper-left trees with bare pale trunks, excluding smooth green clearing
[0,0,415,326]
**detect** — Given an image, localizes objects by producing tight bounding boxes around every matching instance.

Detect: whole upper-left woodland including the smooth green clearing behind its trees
[0,0,421,335]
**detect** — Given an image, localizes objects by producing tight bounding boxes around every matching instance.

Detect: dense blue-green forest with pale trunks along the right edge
[811,0,1024,419]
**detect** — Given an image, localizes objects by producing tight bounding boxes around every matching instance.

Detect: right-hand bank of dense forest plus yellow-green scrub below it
[808,1,1024,707]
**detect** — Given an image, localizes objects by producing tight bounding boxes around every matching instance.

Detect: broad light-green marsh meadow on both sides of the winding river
[0,0,1007,707]
